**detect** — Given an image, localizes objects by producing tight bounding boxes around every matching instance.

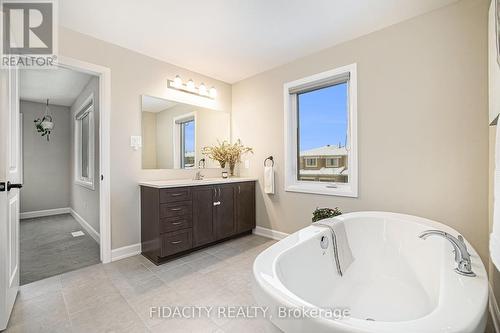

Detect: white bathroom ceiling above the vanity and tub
[59,0,456,83]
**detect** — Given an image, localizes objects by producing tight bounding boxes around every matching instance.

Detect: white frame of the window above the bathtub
[283,63,358,198]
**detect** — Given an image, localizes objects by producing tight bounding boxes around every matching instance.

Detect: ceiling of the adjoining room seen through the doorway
[19,67,91,106]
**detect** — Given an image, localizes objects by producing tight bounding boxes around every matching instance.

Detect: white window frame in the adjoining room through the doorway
[74,94,95,191]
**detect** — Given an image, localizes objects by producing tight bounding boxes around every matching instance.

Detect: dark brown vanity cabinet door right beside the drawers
[192,186,215,247]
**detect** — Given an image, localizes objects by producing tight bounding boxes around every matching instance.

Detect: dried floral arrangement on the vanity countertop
[202,139,253,176]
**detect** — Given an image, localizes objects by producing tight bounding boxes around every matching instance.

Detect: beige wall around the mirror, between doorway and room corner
[59,28,231,249]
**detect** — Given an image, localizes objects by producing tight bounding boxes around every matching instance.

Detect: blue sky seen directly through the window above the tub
[298,83,347,151]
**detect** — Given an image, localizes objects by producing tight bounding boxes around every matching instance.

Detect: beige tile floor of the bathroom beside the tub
[7,235,278,333]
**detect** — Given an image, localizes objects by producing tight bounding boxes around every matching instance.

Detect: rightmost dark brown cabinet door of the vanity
[235,182,255,232]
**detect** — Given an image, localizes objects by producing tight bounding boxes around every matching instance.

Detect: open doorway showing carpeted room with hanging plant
[19,67,100,285]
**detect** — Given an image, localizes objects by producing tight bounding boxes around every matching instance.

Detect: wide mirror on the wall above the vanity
[141,95,231,169]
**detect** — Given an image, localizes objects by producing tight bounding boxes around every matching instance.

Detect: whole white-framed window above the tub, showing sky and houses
[284,64,358,197]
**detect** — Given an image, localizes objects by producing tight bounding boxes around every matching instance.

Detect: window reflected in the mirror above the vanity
[174,113,196,169]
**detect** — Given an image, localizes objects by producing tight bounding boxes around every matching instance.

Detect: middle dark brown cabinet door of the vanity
[214,184,236,239]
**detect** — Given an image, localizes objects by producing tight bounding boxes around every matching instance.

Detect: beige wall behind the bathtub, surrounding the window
[232,0,489,262]
